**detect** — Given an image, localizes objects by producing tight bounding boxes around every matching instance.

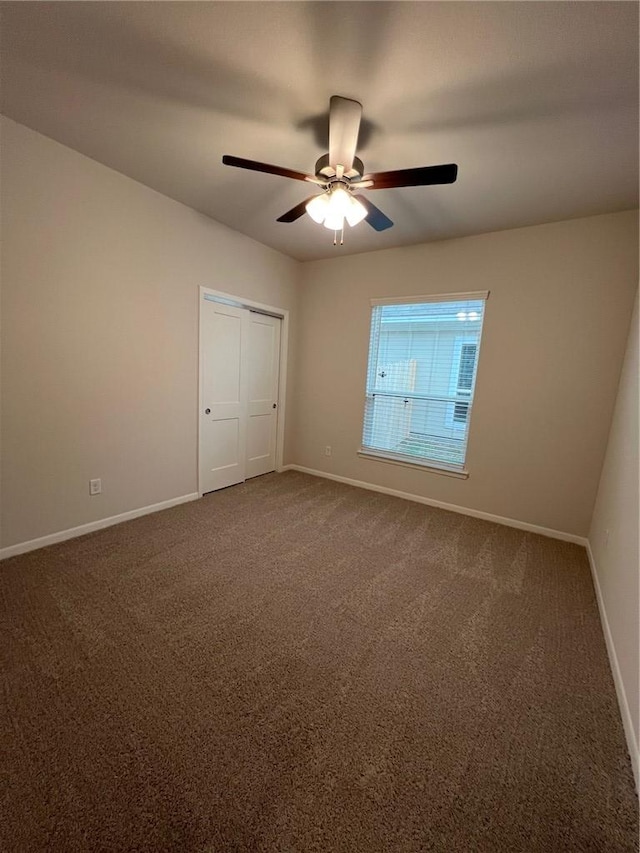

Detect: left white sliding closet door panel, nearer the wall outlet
[200,300,249,494]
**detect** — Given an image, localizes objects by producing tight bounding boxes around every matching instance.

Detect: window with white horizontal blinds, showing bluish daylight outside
[361,293,488,475]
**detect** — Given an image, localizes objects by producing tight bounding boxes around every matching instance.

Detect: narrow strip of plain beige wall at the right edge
[589,296,640,781]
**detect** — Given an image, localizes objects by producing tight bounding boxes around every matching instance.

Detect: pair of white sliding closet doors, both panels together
[200,296,281,494]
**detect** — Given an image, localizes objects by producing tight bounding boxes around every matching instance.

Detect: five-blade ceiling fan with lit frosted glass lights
[222,95,458,243]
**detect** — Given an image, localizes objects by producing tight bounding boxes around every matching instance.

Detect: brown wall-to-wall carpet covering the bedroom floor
[0,472,638,853]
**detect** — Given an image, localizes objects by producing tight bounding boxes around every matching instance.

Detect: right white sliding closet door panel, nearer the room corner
[246,312,281,477]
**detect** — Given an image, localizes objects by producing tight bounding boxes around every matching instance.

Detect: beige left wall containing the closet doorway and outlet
[1,119,298,546]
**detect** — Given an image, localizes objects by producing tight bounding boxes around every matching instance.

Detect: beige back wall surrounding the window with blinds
[293,211,638,536]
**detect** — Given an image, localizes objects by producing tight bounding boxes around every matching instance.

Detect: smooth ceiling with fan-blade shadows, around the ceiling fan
[0,2,638,260]
